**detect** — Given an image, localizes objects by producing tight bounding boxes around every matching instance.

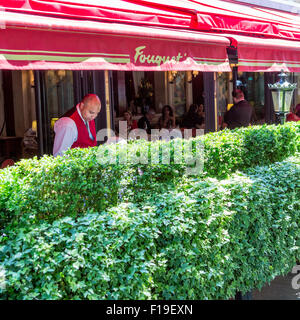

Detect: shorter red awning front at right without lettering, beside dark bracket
[229,35,300,72]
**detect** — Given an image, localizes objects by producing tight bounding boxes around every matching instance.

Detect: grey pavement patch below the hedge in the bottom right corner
[252,264,300,300]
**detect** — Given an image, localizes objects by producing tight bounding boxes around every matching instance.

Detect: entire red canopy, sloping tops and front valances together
[0,0,300,71]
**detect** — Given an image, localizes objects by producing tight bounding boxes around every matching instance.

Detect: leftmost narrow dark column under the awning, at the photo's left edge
[0,70,16,137]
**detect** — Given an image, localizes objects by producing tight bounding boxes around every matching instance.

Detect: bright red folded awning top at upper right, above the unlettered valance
[134,0,300,40]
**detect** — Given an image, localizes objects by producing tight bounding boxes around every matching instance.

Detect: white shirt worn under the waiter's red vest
[53,104,94,157]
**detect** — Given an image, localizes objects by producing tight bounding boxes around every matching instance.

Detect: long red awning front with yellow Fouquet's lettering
[0,12,230,71]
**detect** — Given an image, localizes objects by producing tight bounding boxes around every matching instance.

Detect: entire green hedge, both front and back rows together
[0,123,300,299]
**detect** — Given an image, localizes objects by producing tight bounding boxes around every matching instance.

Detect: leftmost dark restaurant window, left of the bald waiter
[0,70,38,168]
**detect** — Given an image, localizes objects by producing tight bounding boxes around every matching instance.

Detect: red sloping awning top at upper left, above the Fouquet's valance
[0,0,191,28]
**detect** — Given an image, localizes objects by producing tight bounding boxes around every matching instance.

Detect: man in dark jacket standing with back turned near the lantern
[223,89,254,129]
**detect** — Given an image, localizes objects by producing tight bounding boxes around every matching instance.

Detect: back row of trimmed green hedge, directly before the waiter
[0,123,300,228]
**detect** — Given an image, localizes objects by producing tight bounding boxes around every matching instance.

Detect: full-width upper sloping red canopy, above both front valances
[0,0,300,40]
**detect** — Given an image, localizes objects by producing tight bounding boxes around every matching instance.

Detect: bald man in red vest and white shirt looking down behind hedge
[53,94,101,157]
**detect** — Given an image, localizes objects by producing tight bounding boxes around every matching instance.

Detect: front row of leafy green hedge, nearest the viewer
[0,155,300,299]
